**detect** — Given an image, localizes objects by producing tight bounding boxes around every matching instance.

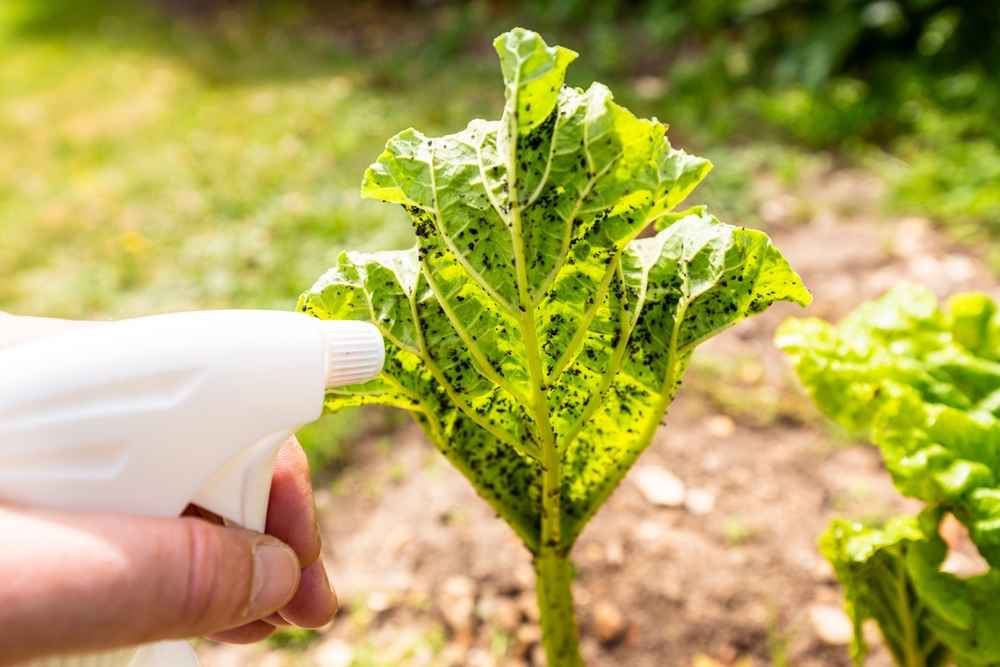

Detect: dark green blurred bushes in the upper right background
[500,0,1000,236]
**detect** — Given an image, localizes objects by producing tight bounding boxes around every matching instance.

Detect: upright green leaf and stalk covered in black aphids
[299,29,810,667]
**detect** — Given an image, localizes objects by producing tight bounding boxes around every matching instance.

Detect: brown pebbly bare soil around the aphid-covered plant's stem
[199,171,997,667]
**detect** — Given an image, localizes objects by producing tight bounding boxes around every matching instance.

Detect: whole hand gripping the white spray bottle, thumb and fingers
[0,313,337,666]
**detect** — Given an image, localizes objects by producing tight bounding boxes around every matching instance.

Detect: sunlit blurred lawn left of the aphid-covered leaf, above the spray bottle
[0,0,502,319]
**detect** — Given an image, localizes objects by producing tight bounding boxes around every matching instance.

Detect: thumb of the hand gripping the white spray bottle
[0,506,301,665]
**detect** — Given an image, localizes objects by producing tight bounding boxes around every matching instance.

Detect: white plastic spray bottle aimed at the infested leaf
[0,310,385,667]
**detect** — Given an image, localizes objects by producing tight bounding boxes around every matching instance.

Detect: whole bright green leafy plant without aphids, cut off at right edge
[777,285,1000,667]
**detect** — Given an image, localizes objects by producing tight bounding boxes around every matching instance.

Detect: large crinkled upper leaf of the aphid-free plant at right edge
[777,286,1000,567]
